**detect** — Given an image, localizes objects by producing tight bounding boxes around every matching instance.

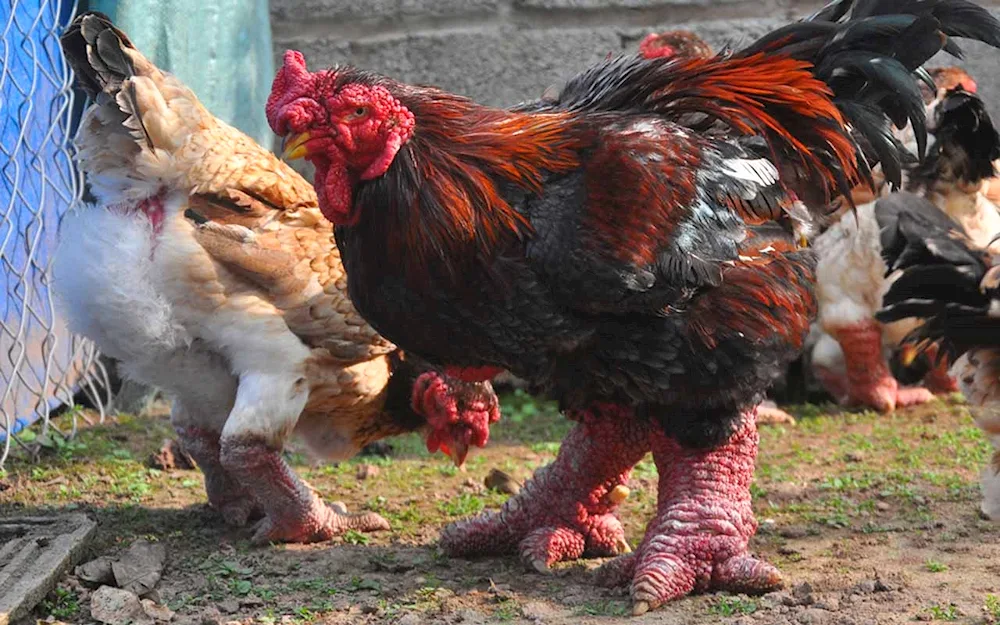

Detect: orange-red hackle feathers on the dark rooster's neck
[394,89,580,274]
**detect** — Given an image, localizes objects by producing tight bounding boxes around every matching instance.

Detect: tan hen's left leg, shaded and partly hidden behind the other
[176,427,262,527]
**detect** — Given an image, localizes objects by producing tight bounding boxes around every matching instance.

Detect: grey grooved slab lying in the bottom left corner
[0,514,97,625]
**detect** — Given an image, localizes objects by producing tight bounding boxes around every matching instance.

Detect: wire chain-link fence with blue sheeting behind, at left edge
[0,0,106,467]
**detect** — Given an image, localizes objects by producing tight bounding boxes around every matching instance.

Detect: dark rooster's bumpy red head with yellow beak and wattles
[267,50,414,225]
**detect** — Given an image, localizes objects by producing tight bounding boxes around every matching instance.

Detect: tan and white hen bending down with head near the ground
[55,13,499,542]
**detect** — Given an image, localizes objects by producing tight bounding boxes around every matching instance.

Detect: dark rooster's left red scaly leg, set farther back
[441,405,649,572]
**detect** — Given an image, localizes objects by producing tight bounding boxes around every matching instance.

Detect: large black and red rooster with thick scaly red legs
[267,0,1000,614]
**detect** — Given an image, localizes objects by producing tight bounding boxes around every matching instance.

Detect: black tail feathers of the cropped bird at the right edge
[875,193,1000,360]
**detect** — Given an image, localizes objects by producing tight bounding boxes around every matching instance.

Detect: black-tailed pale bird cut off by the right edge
[876,196,1000,521]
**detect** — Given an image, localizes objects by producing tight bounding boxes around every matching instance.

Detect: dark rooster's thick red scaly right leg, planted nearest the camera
[598,414,783,615]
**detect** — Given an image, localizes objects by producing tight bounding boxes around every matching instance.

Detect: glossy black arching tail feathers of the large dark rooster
[739,0,1000,193]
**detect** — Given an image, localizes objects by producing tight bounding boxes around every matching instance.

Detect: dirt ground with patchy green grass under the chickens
[0,395,1000,625]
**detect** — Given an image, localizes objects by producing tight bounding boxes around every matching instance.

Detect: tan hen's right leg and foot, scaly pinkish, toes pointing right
[221,439,389,544]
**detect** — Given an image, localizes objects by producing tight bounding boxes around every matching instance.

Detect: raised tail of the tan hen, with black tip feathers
[59,12,217,201]
